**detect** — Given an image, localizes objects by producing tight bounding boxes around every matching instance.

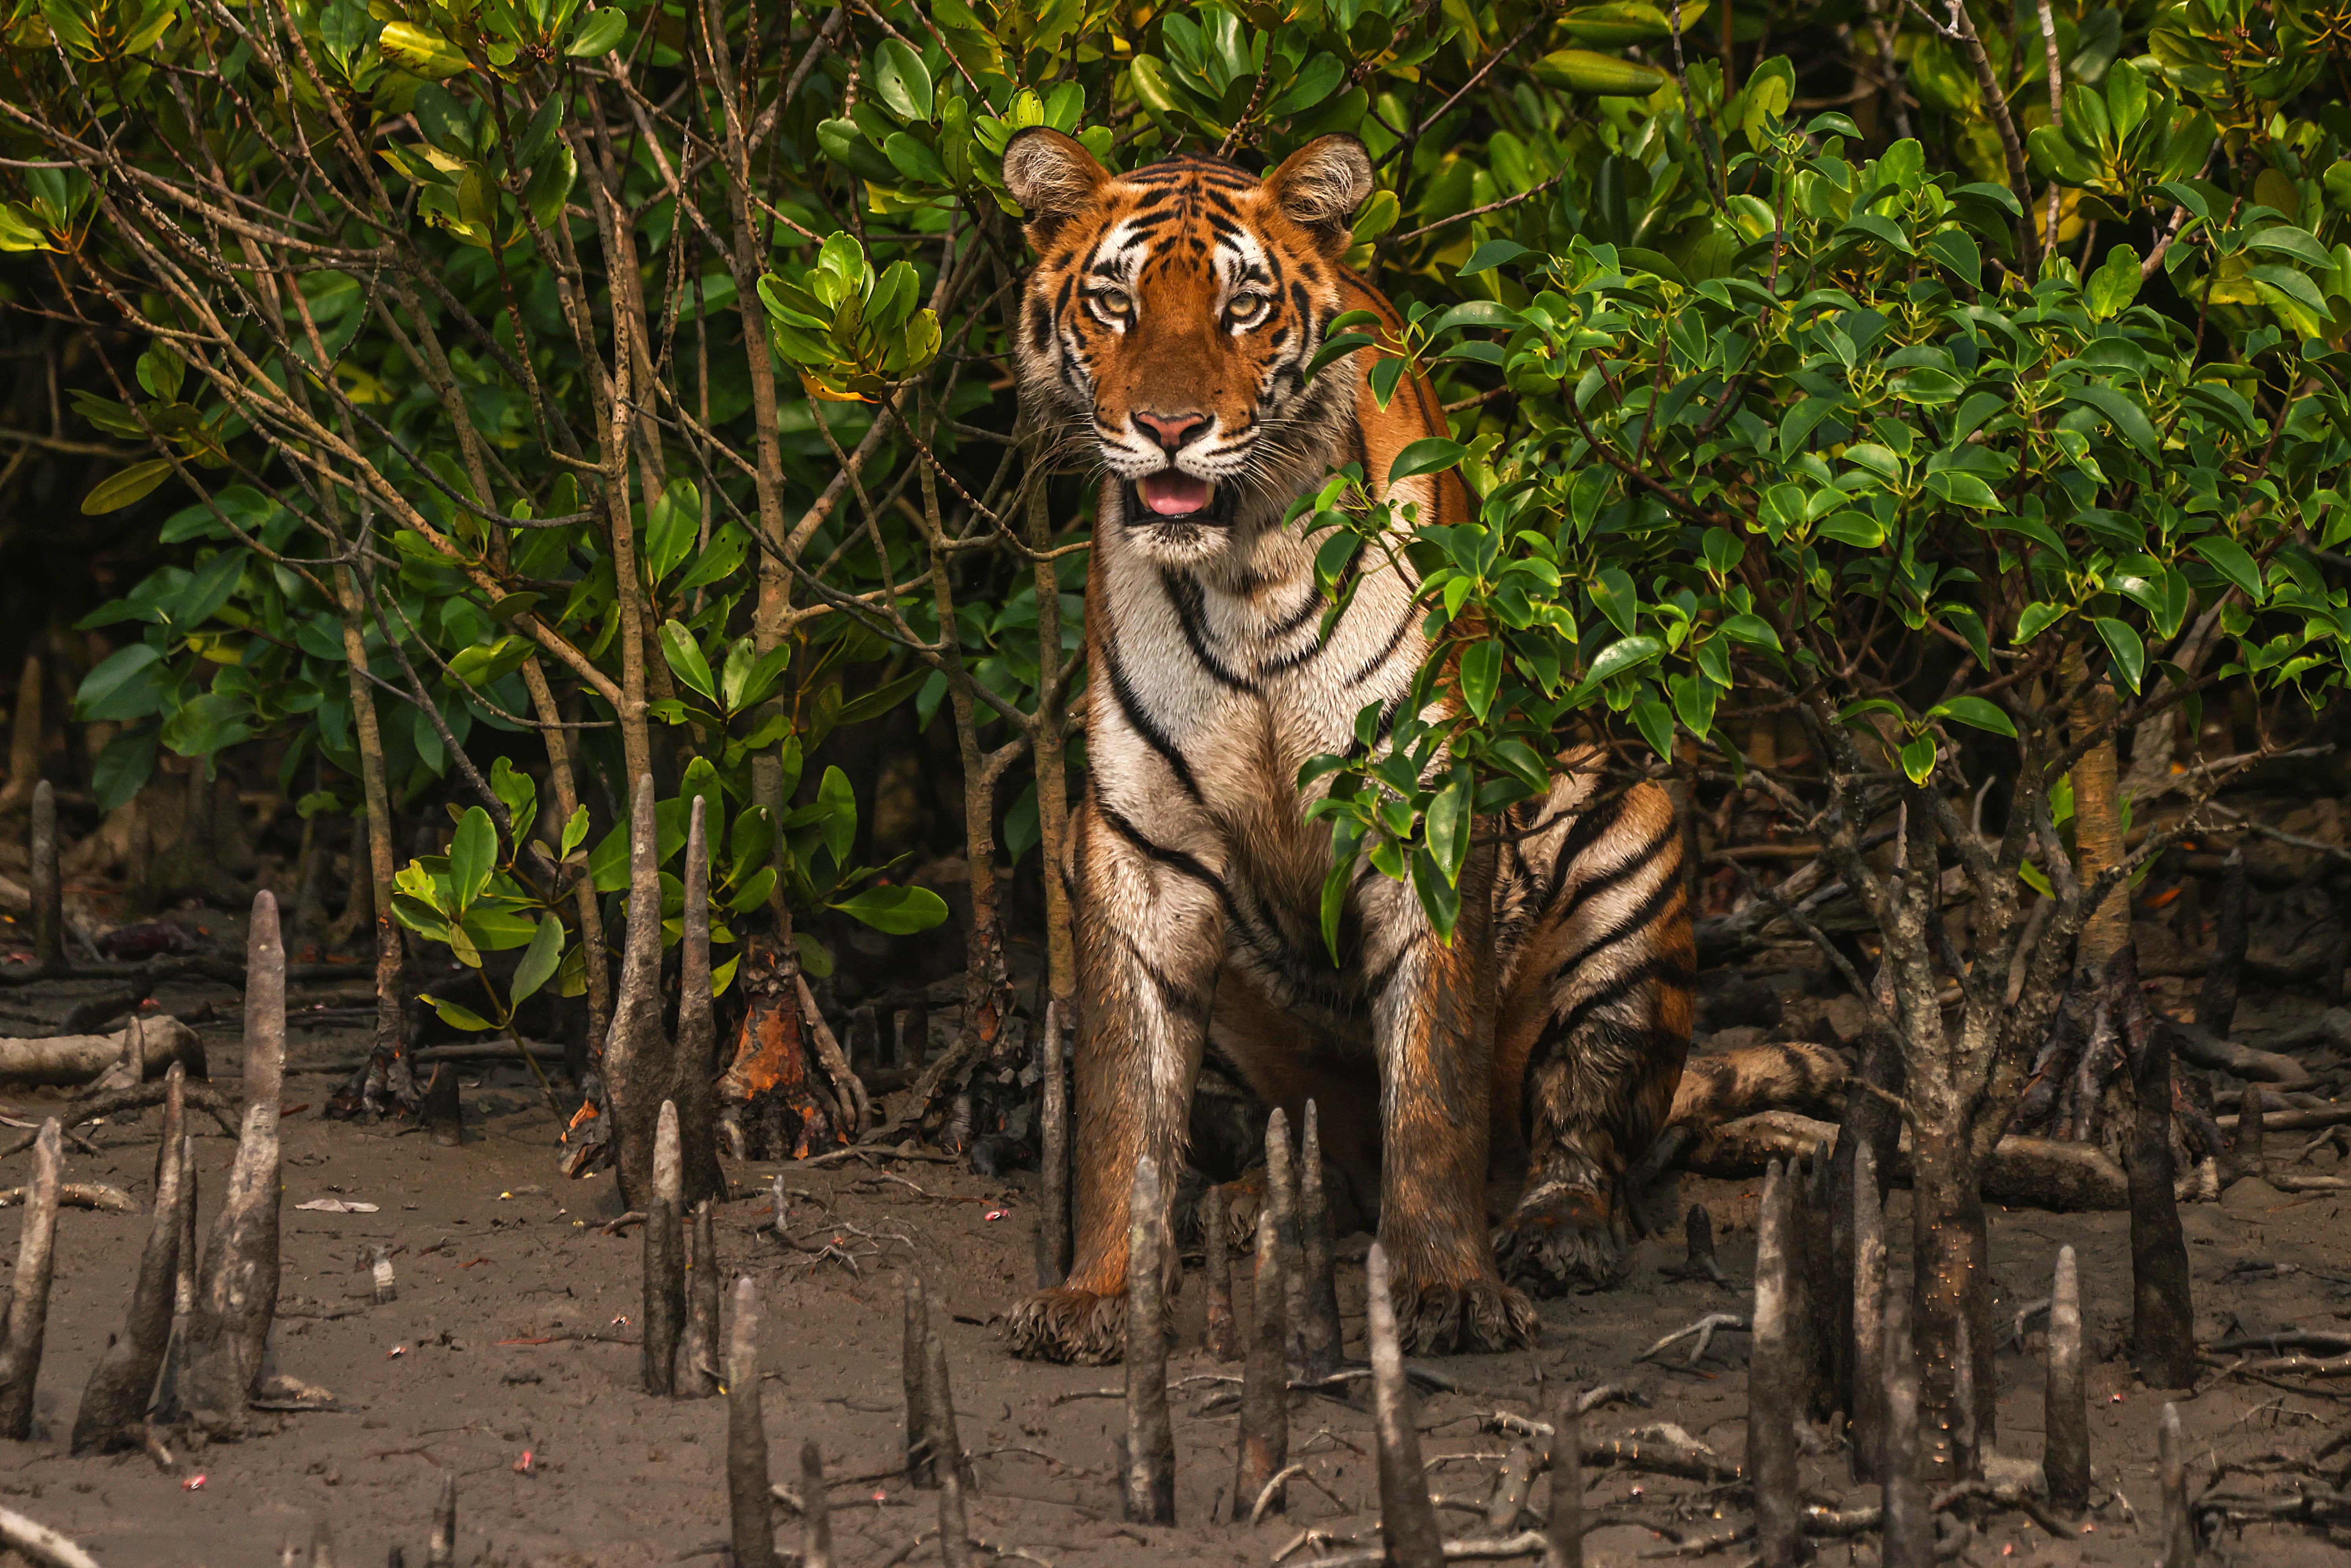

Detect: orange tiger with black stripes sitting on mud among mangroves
[1004,127,1695,1364]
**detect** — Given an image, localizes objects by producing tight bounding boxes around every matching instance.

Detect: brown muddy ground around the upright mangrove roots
[0,969,2351,1568]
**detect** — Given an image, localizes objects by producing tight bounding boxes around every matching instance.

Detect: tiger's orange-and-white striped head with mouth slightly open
[1004,129,1373,560]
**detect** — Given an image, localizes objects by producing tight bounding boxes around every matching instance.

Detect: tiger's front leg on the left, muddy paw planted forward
[1006,794,1225,1366]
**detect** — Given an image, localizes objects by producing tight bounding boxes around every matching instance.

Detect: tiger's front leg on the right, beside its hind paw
[1368,872,1535,1354]
